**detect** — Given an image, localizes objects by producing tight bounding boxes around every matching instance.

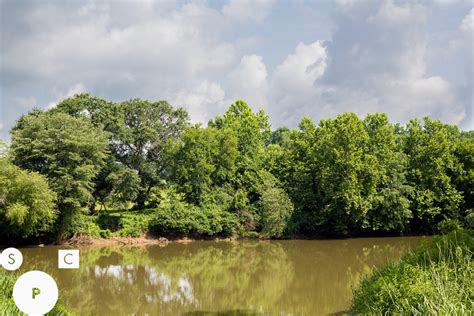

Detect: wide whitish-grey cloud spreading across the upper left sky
[0,3,235,97]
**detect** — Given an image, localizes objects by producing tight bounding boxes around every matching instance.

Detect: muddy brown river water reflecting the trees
[18,238,419,315]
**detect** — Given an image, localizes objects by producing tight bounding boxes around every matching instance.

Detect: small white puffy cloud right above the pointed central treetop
[228,55,268,108]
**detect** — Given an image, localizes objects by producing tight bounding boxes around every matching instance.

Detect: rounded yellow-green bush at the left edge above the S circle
[0,158,57,238]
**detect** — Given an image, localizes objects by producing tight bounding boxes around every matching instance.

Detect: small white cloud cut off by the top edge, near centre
[222,0,275,23]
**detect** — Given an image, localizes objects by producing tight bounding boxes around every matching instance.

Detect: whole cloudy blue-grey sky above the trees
[0,0,474,142]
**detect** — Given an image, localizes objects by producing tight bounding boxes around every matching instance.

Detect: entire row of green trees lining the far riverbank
[0,94,474,242]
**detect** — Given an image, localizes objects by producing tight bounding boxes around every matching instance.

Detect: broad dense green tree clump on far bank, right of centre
[280,113,412,233]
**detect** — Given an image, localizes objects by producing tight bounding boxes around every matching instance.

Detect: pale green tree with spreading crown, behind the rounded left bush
[11,111,107,233]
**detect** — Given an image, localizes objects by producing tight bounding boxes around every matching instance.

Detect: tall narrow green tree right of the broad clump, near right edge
[404,118,462,232]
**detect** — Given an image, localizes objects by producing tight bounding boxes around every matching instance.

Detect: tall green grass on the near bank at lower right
[350,231,474,315]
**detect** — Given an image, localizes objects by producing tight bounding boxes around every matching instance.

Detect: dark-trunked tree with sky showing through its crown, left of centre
[111,99,188,208]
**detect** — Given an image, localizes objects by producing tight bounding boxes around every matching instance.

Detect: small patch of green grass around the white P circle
[0,269,75,316]
